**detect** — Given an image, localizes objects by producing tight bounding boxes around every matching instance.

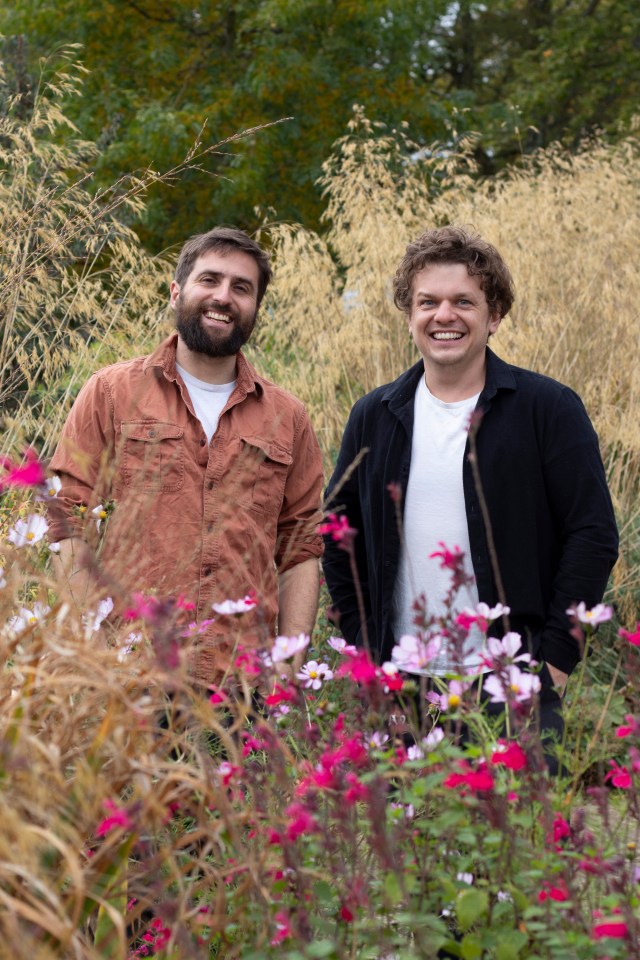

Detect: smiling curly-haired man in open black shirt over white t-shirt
[324,226,618,764]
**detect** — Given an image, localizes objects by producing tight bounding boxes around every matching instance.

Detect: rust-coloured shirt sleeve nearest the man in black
[275,409,323,573]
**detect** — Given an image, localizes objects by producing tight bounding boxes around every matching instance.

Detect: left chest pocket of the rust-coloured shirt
[122,420,184,492]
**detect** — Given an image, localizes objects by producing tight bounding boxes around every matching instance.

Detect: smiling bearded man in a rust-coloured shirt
[49,227,322,684]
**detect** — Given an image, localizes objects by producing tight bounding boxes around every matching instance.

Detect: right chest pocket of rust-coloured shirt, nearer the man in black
[237,436,293,516]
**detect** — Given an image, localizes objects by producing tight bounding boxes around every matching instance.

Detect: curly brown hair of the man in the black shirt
[393,225,515,319]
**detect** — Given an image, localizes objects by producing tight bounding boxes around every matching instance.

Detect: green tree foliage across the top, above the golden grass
[0,0,640,250]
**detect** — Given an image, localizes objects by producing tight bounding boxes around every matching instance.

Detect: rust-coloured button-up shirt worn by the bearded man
[49,334,322,682]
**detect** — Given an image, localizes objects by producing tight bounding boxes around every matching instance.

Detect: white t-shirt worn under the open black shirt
[394,377,483,676]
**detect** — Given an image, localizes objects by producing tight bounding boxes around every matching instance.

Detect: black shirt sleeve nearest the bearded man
[323,401,372,644]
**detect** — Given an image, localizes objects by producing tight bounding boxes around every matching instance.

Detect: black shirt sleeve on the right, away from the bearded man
[539,388,618,673]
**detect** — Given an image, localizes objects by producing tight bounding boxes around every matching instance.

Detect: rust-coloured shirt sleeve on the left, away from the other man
[48,374,114,541]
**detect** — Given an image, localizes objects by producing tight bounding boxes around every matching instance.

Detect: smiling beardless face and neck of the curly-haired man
[409,263,500,383]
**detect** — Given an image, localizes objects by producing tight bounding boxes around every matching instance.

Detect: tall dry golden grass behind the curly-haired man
[260,114,640,608]
